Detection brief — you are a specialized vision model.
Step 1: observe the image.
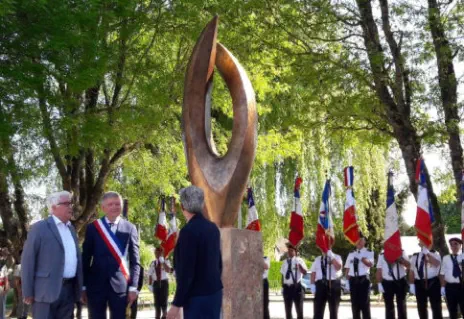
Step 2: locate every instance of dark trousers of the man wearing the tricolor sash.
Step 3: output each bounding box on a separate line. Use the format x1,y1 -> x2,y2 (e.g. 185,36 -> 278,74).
87,284 -> 127,319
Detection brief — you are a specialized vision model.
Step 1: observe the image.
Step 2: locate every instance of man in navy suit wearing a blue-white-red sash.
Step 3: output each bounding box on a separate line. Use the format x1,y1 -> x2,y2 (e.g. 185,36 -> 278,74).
82,192 -> 140,319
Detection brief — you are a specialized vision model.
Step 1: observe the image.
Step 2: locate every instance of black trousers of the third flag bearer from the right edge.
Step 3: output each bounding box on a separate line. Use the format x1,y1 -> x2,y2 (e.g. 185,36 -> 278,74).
382,278 -> 409,319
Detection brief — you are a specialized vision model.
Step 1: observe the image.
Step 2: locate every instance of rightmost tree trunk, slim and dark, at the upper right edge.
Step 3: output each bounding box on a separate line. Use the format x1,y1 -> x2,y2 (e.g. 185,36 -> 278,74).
428,0 -> 464,207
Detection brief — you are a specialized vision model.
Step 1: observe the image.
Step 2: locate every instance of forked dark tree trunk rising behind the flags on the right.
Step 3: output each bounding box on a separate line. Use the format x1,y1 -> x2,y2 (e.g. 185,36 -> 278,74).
356,0 -> 448,253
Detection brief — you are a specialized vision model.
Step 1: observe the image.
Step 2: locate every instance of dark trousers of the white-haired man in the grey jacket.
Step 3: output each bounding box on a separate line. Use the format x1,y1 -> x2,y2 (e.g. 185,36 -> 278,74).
32,281 -> 75,319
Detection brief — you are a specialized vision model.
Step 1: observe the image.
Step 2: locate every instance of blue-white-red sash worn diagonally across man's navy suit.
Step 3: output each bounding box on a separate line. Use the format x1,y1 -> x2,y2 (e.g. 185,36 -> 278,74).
93,217 -> 130,281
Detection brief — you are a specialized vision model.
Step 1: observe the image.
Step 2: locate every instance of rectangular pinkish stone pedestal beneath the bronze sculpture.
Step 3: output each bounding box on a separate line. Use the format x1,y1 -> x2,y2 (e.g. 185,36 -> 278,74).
221,228 -> 264,319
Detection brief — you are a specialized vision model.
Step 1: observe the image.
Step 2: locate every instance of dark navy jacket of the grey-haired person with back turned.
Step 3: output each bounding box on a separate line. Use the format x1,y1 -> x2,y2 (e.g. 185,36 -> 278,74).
172,214 -> 222,307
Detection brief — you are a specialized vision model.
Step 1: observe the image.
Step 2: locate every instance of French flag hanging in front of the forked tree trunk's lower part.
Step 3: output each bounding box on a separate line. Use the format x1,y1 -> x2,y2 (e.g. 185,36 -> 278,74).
414,158 -> 435,248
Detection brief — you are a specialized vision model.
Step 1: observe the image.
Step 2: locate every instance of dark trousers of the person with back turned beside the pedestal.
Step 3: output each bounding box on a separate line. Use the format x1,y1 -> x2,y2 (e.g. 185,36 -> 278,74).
184,289 -> 222,319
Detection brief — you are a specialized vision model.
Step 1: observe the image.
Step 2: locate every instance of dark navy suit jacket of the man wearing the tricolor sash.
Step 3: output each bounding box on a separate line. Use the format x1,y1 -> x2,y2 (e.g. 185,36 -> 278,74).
82,218 -> 140,293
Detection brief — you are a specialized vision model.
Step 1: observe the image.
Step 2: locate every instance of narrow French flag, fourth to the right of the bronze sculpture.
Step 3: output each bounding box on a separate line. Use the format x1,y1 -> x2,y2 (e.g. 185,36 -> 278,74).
343,166 -> 360,245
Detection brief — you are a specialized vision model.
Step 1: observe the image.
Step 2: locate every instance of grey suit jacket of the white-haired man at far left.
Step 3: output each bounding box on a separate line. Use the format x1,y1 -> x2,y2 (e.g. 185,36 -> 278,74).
21,217 -> 83,303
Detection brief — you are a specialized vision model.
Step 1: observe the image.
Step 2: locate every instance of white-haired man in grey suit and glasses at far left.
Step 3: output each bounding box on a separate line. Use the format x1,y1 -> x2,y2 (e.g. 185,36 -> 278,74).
21,191 -> 83,319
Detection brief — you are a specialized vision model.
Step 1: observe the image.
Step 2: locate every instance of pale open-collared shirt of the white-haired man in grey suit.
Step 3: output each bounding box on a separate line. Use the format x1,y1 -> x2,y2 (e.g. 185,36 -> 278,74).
52,215 -> 77,278
